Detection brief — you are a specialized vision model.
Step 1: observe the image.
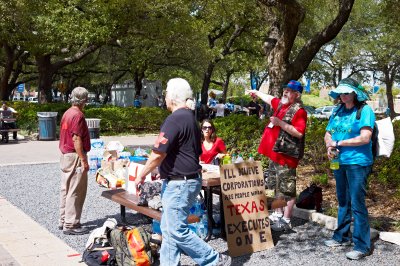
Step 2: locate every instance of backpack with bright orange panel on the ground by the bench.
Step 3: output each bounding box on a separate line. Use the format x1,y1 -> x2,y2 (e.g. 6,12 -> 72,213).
109,226 -> 154,266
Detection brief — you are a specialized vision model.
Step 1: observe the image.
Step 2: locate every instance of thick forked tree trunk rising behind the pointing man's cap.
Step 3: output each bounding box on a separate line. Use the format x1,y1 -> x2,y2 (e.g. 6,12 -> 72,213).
259,0 -> 354,96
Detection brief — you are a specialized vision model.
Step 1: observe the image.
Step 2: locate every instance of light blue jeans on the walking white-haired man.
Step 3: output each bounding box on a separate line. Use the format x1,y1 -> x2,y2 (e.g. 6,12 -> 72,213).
160,178 -> 219,266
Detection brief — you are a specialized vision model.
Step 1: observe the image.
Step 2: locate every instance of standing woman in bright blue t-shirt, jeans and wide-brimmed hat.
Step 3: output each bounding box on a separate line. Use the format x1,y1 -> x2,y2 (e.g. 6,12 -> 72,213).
324,78 -> 375,260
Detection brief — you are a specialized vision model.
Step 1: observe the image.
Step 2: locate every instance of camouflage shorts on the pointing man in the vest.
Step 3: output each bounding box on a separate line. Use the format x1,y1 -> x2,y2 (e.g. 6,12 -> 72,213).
265,161 -> 296,198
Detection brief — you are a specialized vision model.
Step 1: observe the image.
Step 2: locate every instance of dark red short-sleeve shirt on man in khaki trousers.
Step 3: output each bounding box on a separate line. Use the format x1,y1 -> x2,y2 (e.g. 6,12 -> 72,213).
59,107 -> 90,154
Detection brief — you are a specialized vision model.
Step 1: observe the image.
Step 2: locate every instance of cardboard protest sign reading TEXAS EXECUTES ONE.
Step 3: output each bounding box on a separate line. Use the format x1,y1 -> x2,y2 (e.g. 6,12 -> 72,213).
221,162 -> 274,257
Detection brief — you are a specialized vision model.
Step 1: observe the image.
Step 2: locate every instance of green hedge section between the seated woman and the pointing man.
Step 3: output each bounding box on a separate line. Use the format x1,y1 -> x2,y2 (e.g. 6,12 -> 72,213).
214,115 -> 267,167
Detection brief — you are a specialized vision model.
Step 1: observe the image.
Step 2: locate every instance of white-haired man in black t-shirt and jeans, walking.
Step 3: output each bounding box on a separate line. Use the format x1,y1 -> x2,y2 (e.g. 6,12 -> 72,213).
135,78 -> 231,266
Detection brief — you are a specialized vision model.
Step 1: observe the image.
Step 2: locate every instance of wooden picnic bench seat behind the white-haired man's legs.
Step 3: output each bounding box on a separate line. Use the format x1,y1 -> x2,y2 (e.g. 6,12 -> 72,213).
101,189 -> 200,223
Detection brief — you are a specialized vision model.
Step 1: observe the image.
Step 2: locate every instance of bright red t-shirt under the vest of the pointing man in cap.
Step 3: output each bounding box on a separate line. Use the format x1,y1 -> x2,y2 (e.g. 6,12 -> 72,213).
258,98 -> 307,168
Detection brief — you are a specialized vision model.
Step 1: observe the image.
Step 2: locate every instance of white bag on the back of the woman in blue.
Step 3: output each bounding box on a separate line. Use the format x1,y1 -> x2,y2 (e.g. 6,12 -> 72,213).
375,117 -> 395,158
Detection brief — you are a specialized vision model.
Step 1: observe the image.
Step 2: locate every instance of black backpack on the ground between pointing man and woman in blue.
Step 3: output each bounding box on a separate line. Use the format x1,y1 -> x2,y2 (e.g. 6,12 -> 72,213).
296,184 -> 322,212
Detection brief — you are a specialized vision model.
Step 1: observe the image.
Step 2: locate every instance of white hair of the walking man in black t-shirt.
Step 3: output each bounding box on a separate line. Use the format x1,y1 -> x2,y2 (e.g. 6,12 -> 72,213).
166,78 -> 193,109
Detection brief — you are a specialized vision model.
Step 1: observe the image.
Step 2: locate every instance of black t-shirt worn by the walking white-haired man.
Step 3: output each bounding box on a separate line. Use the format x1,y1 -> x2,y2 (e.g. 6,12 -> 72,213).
153,108 -> 201,179
